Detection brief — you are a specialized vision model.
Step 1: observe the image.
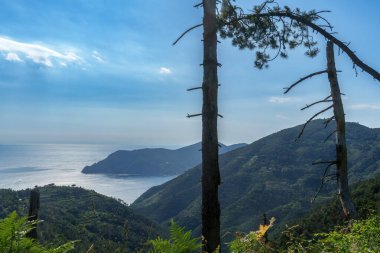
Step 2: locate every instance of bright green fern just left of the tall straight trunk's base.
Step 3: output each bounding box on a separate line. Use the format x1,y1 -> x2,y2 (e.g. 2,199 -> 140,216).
149,220 -> 202,253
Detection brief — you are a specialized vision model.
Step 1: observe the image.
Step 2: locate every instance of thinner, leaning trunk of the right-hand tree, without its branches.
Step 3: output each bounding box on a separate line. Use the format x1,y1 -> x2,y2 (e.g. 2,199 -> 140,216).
326,41 -> 356,219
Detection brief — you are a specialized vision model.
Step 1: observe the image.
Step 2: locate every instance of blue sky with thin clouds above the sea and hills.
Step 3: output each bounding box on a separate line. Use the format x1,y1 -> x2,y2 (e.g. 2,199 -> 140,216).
0,0 -> 380,147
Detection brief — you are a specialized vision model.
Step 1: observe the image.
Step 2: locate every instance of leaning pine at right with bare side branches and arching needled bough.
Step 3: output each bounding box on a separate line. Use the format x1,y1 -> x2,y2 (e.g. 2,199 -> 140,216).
219,0 -> 380,218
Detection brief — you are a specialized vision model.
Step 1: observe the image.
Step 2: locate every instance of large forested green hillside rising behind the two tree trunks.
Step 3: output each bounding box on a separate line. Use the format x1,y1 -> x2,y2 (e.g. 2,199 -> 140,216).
131,120 -> 380,237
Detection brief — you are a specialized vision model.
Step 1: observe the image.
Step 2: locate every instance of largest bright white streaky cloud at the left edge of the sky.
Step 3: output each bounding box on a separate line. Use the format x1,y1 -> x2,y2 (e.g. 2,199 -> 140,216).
0,37 -> 81,67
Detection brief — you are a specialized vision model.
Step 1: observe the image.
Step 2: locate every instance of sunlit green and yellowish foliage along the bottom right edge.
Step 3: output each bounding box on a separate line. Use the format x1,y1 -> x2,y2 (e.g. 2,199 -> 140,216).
229,216 -> 380,253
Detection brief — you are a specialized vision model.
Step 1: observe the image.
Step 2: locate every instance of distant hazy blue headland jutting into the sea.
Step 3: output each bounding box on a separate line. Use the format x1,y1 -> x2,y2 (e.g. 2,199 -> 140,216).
82,143 -> 247,176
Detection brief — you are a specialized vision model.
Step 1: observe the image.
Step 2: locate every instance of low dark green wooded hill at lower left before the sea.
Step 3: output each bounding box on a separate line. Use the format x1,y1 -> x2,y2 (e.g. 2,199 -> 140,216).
0,185 -> 163,253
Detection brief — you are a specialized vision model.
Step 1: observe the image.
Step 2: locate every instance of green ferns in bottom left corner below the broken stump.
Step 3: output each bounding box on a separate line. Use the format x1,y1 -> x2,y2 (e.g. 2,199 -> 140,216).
0,212 -> 75,253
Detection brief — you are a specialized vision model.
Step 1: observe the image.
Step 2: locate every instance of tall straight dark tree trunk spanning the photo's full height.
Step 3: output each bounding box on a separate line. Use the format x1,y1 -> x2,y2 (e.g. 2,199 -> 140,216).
202,0 -> 220,253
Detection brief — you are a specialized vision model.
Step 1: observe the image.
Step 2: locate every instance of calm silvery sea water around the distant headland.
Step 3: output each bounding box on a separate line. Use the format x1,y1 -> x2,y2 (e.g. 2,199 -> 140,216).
0,144 -> 173,203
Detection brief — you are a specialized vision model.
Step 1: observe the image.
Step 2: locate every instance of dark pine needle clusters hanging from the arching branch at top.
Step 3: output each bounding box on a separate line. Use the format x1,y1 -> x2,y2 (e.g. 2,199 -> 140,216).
218,0 -> 326,69
